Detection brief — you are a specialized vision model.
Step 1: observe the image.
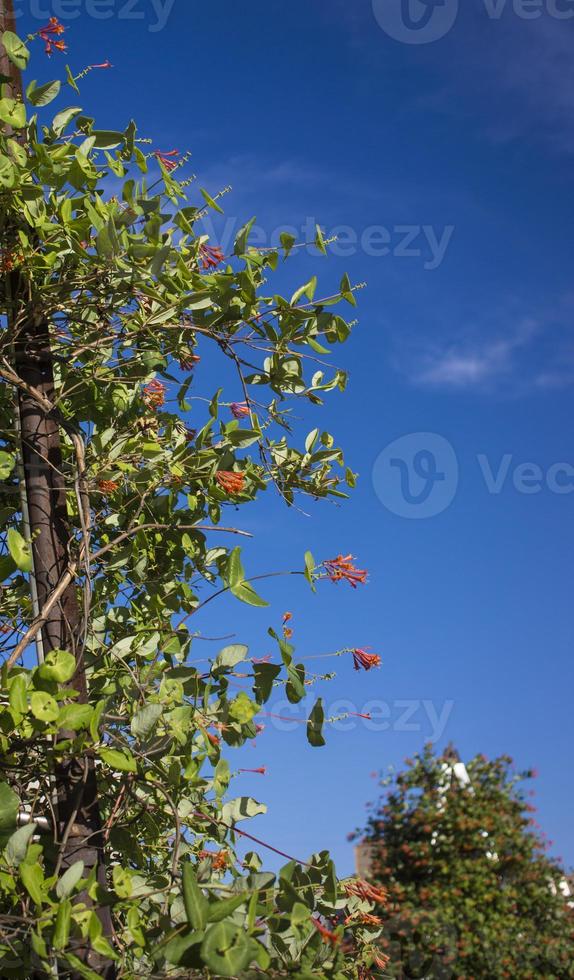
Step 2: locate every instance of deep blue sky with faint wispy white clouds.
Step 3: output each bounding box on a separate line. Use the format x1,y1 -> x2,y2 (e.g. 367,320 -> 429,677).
18,0 -> 574,872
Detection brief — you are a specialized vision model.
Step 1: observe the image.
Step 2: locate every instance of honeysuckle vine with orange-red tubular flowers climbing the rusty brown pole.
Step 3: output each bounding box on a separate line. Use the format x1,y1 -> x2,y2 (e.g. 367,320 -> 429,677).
0,18 -> 392,980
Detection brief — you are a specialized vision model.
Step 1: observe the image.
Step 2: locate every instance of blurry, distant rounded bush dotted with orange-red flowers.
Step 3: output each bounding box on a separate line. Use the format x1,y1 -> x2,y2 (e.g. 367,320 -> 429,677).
361,746 -> 574,980
